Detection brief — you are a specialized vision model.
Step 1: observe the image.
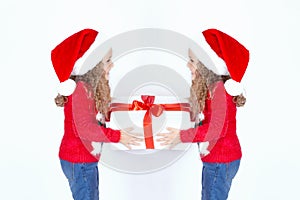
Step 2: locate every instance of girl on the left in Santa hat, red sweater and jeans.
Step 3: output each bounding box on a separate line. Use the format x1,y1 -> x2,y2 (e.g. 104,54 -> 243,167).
51,30 -> 140,200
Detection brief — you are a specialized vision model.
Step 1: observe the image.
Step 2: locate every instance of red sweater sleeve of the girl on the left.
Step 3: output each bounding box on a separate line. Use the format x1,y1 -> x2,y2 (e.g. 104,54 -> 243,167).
72,82 -> 120,142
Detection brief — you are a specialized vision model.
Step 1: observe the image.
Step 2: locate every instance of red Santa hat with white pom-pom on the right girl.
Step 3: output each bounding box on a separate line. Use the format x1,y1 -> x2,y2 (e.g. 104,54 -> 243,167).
202,29 -> 249,96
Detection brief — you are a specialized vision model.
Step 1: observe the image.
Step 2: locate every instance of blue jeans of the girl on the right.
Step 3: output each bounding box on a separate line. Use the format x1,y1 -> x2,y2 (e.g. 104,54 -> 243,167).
202,160 -> 240,200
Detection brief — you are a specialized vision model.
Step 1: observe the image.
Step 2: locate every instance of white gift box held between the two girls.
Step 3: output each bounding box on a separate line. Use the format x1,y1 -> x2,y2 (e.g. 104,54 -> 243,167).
107,96 -> 195,150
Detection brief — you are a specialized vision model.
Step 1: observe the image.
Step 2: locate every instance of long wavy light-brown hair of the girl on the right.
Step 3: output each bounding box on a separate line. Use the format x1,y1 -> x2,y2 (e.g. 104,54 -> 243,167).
189,60 -> 246,117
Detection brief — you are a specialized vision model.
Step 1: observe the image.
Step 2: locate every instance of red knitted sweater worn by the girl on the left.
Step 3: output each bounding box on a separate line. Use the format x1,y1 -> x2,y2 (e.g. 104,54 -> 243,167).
59,81 -> 120,163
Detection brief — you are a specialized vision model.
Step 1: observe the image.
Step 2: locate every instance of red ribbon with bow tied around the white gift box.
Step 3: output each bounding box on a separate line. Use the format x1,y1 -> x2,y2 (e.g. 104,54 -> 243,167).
111,95 -> 190,149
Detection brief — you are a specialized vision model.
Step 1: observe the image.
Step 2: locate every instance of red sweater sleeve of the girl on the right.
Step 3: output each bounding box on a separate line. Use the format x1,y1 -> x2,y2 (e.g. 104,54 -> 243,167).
180,82 -> 228,142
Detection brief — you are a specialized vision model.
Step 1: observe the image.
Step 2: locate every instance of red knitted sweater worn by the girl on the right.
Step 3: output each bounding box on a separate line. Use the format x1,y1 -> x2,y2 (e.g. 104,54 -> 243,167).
180,93 -> 242,163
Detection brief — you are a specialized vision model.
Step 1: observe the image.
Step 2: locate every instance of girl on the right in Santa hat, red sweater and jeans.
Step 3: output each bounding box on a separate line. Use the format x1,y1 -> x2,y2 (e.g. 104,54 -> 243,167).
159,29 -> 249,200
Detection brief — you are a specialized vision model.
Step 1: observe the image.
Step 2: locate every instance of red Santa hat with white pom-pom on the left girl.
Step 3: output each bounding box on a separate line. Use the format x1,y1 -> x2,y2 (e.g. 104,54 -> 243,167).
51,29 -> 98,96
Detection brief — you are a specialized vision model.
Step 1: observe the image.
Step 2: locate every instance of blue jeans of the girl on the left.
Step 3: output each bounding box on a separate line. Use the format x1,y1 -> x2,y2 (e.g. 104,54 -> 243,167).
60,160 -> 99,200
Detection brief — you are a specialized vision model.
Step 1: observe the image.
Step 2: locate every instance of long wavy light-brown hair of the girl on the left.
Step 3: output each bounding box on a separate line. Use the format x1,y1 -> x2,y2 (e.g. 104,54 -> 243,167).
54,61 -> 111,117
